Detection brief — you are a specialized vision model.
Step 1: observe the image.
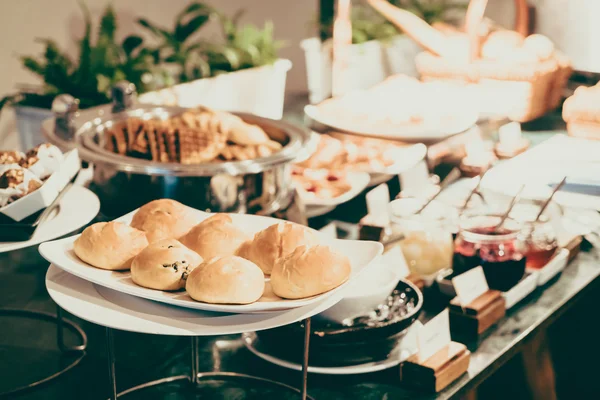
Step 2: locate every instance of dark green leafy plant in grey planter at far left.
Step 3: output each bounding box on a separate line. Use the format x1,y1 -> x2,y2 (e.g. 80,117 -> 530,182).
0,4 -> 154,149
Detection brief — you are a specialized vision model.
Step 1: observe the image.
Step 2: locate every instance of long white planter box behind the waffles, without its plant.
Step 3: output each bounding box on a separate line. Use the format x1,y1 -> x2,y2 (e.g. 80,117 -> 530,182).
139,59 -> 292,119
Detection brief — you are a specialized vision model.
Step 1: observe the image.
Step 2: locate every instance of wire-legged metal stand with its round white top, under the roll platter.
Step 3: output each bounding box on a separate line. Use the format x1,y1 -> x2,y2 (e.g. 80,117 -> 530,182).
46,265 -> 352,400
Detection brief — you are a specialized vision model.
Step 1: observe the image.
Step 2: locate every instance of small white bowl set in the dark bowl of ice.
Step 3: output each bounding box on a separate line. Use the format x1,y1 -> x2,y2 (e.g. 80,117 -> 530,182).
319,258 -> 400,324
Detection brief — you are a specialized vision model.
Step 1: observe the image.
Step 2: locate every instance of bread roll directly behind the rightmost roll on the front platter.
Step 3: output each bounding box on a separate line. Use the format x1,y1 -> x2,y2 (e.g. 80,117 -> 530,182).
238,222 -> 319,275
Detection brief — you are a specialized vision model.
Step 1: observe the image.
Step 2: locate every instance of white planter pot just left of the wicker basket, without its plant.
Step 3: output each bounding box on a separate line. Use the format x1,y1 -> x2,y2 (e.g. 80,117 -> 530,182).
300,35 -> 419,104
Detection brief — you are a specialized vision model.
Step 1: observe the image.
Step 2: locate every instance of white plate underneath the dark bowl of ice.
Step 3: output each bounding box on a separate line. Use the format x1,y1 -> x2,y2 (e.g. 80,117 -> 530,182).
242,333 -> 416,375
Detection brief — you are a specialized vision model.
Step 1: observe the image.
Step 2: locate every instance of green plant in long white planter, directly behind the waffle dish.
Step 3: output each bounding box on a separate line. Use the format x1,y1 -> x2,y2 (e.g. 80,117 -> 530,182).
138,3 -> 291,119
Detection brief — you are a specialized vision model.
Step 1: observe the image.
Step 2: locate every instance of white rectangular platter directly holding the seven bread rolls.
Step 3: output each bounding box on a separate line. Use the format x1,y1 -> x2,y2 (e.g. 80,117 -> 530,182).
39,210 -> 383,313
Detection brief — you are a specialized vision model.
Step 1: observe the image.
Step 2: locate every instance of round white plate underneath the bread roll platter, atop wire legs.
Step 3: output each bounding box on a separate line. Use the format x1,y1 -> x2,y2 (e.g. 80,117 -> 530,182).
46,265 -> 358,338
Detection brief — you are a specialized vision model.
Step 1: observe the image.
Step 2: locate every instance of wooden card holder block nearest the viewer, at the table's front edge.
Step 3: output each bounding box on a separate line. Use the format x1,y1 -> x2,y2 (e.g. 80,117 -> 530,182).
400,342 -> 471,393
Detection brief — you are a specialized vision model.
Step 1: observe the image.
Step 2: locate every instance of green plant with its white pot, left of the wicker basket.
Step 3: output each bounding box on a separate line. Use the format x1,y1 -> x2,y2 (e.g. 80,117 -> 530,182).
301,0 -> 465,103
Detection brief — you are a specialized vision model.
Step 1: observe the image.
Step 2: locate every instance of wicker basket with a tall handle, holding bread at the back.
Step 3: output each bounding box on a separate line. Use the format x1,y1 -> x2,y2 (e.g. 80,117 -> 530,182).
416,0 -> 572,122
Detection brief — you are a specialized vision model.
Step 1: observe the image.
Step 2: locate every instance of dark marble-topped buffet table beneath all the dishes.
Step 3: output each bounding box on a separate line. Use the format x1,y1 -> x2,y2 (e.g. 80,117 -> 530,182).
0,99 -> 600,400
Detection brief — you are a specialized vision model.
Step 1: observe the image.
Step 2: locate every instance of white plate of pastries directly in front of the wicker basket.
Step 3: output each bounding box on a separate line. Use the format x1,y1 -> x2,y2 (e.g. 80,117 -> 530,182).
304,105 -> 478,143
